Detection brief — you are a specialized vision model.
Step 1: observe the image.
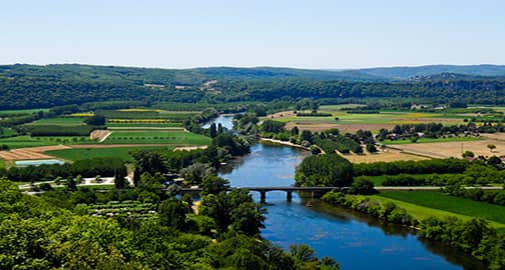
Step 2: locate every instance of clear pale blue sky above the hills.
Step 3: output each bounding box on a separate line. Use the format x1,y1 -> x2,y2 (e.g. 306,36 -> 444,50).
0,0 -> 505,68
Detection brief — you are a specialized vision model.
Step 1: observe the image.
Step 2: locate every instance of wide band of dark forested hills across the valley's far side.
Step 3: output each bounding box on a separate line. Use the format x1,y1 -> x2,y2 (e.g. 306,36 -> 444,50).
0,65 -> 505,109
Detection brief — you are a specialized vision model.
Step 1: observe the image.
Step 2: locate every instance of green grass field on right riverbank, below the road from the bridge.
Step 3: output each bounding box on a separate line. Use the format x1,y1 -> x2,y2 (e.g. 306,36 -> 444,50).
377,191 -> 505,226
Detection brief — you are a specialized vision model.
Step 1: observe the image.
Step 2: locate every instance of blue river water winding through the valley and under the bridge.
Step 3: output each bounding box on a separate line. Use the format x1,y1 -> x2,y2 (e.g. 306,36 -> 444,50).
208,117 -> 486,270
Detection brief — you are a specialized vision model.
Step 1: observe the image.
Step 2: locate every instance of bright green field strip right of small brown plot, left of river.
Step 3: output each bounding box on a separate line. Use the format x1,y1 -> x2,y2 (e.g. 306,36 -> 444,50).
103,130 -> 211,145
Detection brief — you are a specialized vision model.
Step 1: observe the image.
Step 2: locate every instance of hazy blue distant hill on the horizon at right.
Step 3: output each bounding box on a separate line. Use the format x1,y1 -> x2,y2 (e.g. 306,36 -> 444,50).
356,65 -> 505,80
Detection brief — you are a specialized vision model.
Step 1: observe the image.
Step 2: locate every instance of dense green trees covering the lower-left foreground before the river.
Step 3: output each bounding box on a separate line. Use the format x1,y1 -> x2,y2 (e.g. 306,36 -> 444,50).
0,174 -> 338,269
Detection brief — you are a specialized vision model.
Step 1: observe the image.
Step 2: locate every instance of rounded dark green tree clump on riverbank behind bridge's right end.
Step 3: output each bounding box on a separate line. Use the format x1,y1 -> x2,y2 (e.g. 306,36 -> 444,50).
295,154 -> 352,186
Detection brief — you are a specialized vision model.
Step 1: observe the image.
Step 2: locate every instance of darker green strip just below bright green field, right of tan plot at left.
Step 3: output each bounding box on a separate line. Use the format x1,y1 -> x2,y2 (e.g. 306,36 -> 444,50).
45,146 -> 174,161
